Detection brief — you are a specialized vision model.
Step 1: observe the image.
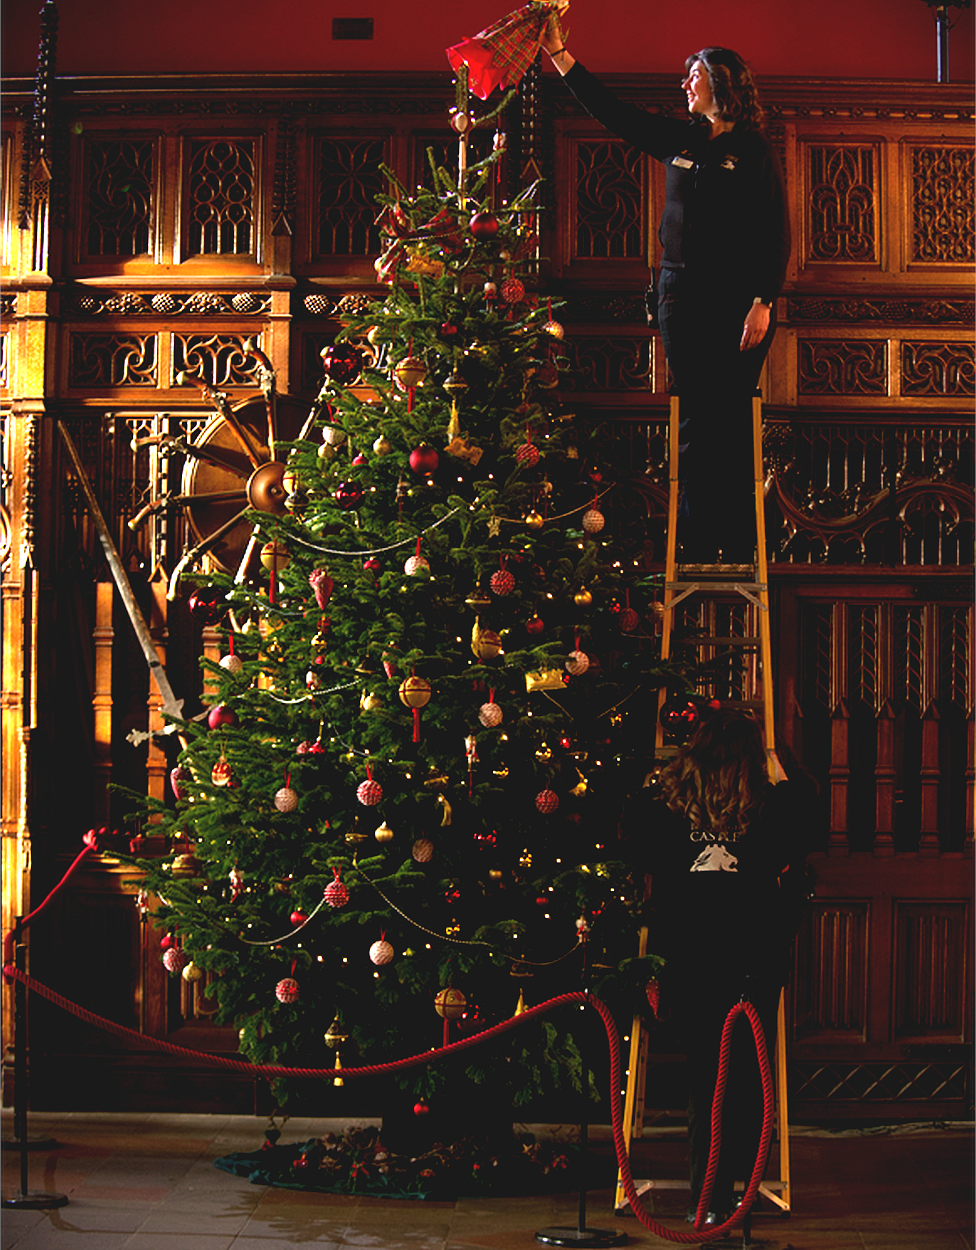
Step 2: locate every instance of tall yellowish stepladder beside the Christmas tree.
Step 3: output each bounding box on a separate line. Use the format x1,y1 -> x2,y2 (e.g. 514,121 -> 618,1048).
614,393 -> 791,1211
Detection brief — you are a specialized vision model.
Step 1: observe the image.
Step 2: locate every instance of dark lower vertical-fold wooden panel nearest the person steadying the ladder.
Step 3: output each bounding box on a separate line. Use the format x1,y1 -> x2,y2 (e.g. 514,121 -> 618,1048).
794,899 -> 870,1039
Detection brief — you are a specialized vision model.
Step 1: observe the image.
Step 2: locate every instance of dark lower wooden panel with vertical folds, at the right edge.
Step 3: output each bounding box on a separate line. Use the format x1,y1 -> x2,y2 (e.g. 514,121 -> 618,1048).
895,901 -> 966,1041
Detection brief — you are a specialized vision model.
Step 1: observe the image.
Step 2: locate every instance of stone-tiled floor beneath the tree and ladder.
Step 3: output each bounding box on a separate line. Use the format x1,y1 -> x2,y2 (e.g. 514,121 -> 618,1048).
0,1113 -> 975,1250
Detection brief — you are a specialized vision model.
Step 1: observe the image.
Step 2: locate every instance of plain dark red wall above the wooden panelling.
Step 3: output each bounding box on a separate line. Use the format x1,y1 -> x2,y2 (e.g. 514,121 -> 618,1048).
0,0 -> 976,81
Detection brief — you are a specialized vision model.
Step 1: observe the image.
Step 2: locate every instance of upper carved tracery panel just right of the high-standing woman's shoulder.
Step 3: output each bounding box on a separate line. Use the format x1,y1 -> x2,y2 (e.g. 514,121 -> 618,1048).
807,144 -> 880,265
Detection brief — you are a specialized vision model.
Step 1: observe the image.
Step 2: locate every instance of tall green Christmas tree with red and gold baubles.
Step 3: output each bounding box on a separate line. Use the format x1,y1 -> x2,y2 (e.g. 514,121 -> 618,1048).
121,100 -> 666,1135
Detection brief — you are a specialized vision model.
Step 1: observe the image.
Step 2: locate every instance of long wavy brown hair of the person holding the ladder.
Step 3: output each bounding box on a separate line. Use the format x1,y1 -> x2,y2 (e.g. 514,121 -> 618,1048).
661,711 -> 770,834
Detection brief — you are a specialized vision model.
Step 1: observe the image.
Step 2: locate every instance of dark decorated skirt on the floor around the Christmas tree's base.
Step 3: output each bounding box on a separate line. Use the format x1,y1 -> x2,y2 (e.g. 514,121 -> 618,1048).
214,1128 -> 615,1200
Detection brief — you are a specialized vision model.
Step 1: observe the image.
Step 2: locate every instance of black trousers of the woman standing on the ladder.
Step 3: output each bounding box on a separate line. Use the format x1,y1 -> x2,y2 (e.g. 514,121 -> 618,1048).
657,269 -> 775,564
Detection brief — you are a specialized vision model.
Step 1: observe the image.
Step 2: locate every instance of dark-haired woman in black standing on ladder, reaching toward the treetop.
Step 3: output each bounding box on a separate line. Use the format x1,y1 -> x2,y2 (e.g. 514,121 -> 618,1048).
542,4 -> 790,564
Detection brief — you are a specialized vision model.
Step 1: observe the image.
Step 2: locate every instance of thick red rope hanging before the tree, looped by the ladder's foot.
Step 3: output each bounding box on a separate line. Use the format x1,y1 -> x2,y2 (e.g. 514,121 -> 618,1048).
4,955 -> 772,1245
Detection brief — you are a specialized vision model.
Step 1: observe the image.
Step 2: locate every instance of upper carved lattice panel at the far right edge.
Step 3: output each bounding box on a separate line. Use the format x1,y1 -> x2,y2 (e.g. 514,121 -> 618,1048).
911,145 -> 976,265
